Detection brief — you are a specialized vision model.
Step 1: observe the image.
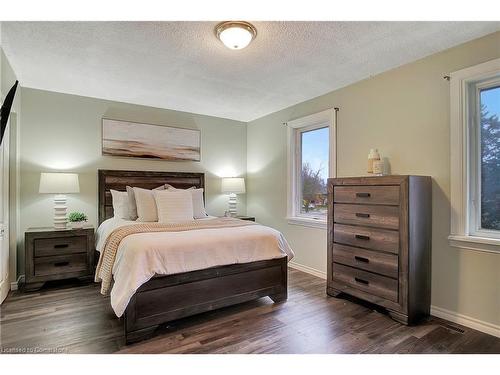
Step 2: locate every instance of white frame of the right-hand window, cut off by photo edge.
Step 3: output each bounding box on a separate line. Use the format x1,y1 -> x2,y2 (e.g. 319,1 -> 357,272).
448,59 -> 500,252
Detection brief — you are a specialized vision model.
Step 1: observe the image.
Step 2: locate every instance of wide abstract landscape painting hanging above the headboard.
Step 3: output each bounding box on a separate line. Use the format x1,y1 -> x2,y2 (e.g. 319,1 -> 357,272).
102,118 -> 201,161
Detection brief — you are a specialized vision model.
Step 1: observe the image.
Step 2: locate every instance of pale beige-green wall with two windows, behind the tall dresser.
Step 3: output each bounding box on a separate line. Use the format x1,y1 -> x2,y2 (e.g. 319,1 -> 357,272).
247,33 -> 500,325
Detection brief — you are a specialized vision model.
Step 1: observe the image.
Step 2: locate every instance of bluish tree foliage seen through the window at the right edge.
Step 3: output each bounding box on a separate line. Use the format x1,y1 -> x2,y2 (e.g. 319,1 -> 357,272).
481,106 -> 500,230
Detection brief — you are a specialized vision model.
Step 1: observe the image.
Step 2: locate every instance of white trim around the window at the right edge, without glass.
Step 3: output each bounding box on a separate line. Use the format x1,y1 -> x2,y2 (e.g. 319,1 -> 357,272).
448,59 -> 500,252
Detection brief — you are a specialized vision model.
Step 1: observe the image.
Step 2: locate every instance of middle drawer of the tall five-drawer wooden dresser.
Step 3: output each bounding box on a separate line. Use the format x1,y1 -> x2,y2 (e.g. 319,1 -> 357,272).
333,224 -> 399,254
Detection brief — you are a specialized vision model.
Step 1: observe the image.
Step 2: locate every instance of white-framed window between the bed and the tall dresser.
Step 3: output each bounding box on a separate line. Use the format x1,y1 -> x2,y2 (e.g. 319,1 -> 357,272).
287,109 -> 335,228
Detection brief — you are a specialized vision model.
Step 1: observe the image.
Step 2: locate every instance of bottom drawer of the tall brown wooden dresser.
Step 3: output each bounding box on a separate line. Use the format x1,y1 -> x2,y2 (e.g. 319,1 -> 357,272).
332,263 -> 398,302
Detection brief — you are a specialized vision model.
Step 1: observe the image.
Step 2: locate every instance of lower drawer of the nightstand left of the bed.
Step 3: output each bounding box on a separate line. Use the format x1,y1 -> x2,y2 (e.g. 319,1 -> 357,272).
35,253 -> 88,276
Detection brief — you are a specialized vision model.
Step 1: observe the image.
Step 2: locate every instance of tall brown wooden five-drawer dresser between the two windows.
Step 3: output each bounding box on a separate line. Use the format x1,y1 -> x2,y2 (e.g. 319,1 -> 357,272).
327,176 -> 432,324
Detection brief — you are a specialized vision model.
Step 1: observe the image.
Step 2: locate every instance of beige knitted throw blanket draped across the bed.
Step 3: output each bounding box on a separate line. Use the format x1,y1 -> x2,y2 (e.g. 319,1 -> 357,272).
95,218 -> 256,295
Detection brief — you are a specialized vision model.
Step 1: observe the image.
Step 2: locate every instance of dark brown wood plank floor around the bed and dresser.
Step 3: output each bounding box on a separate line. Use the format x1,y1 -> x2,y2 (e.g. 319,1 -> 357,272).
0,269 -> 500,353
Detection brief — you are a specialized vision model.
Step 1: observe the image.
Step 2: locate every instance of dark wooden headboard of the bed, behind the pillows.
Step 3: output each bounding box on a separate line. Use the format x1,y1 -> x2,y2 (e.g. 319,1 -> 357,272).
98,169 -> 205,224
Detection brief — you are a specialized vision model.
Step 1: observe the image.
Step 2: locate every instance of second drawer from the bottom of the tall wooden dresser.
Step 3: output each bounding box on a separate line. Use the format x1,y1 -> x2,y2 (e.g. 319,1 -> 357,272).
332,243 -> 398,279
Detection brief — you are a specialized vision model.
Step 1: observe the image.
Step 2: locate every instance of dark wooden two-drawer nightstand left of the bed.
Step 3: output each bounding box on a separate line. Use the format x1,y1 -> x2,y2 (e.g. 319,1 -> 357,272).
24,227 -> 95,291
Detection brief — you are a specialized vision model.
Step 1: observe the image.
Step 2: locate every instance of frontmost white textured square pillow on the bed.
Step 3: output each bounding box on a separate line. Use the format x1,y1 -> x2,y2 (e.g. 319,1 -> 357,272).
153,189 -> 193,224
